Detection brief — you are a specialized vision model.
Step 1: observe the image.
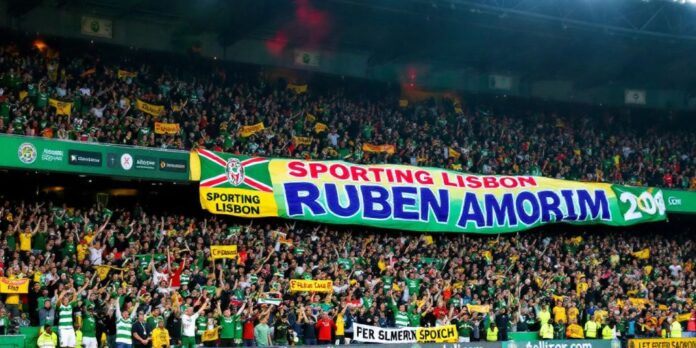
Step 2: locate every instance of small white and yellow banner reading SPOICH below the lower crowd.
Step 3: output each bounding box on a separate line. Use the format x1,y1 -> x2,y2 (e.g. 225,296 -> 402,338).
353,323 -> 459,344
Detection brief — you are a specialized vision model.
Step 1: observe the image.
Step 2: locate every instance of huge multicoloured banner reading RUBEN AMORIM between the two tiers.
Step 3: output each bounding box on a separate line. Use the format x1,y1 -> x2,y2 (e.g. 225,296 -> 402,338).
198,150 -> 665,234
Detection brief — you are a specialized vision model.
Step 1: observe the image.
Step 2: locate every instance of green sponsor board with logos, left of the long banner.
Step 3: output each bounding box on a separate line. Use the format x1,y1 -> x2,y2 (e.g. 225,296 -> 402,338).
0,134 -> 189,181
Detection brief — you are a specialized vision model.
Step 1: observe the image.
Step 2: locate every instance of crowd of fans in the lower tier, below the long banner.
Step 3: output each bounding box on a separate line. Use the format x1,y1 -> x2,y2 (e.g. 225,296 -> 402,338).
0,197 -> 696,347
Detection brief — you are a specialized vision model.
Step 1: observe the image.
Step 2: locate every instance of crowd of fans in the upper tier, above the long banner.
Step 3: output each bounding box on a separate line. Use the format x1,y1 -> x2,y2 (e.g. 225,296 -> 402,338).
0,38 -> 696,189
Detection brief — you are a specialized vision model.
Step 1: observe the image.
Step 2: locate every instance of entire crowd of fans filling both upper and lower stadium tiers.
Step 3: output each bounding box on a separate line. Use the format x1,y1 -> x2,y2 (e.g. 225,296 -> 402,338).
0,36 -> 696,347
